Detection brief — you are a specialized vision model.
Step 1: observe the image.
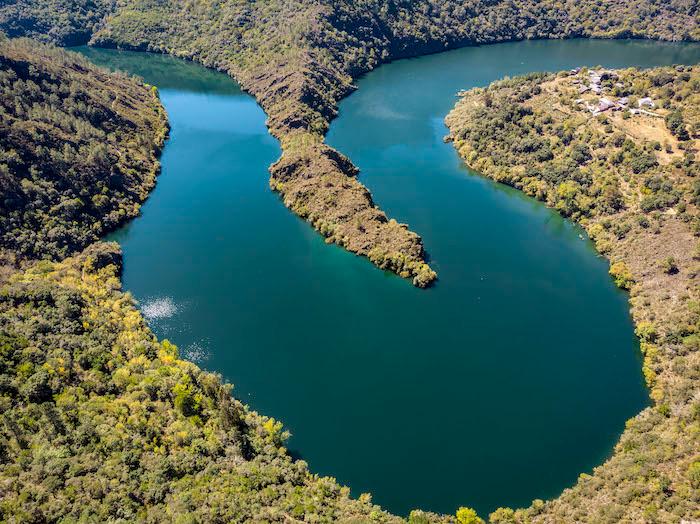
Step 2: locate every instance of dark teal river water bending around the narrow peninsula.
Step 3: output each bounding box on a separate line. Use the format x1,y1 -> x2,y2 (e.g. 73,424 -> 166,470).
75,41 -> 700,515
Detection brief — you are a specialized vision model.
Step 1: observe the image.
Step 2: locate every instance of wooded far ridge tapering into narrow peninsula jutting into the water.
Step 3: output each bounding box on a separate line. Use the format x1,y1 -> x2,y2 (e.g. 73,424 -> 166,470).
0,0 -> 700,286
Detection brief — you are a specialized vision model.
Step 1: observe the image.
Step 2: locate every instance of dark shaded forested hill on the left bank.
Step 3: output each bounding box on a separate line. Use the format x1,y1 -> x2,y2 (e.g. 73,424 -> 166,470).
0,39 -> 167,260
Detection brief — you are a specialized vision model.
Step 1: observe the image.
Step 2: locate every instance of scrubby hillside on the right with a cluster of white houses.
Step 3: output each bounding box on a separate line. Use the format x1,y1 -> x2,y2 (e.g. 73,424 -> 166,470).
446,66 -> 700,522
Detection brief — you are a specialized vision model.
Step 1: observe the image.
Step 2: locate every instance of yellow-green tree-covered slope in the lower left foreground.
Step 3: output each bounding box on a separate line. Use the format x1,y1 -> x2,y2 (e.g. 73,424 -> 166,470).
0,243 -> 426,522
